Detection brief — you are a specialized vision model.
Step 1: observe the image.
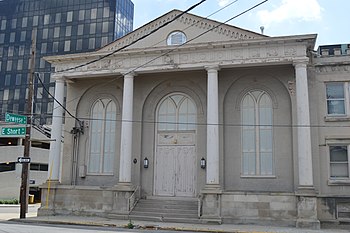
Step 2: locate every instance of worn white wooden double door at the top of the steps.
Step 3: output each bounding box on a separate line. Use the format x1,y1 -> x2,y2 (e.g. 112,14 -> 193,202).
154,132 -> 196,197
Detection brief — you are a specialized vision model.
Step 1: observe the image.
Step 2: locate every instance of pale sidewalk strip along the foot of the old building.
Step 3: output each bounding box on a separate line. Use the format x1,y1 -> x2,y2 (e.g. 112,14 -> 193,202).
10,216 -> 350,233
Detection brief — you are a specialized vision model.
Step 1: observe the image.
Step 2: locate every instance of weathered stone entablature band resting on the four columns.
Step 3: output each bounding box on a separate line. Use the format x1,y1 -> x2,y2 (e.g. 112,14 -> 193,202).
55,44 -> 308,77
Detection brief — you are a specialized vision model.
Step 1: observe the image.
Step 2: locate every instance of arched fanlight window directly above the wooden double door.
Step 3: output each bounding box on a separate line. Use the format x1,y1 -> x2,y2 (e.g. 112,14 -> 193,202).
158,94 -> 197,131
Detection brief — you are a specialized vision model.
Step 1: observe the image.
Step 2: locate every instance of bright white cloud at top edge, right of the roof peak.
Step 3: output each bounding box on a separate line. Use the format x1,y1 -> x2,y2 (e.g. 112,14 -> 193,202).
258,0 -> 322,27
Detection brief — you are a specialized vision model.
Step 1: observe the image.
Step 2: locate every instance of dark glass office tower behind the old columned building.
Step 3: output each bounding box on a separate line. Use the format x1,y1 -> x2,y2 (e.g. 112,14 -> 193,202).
0,0 -> 134,124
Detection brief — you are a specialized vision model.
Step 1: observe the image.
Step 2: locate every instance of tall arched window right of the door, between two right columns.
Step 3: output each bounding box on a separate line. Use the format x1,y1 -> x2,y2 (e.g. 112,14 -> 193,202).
241,90 -> 273,176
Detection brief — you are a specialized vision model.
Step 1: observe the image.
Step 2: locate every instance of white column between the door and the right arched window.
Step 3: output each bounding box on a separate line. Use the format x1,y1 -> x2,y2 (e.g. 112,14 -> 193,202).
206,66 -> 220,186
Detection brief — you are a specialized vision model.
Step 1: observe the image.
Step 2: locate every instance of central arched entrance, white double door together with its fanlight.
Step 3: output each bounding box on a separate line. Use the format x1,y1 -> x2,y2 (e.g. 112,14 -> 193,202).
154,93 -> 197,197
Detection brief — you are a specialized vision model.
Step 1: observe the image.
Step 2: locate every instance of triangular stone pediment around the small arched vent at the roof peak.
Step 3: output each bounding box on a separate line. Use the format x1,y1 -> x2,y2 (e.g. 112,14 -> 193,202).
100,10 -> 266,51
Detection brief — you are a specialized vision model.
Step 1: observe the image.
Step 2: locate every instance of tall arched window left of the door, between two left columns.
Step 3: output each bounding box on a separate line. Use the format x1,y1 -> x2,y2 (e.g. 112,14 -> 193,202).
88,99 -> 116,174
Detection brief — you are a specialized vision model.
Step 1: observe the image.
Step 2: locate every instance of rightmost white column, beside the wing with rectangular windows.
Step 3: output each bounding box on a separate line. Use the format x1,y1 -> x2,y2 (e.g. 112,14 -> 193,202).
294,58 -> 314,188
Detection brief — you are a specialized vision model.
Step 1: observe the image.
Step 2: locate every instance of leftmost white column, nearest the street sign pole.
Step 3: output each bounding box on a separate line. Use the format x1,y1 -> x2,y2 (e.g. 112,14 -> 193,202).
47,77 -> 65,181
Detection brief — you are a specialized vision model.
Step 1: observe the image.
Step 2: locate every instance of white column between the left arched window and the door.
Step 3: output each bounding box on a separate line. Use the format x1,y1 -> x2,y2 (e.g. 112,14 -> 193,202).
119,73 -> 134,184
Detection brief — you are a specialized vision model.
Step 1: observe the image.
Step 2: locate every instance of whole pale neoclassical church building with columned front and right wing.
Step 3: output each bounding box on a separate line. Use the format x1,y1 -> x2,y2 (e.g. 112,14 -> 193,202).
39,10 -> 350,229
